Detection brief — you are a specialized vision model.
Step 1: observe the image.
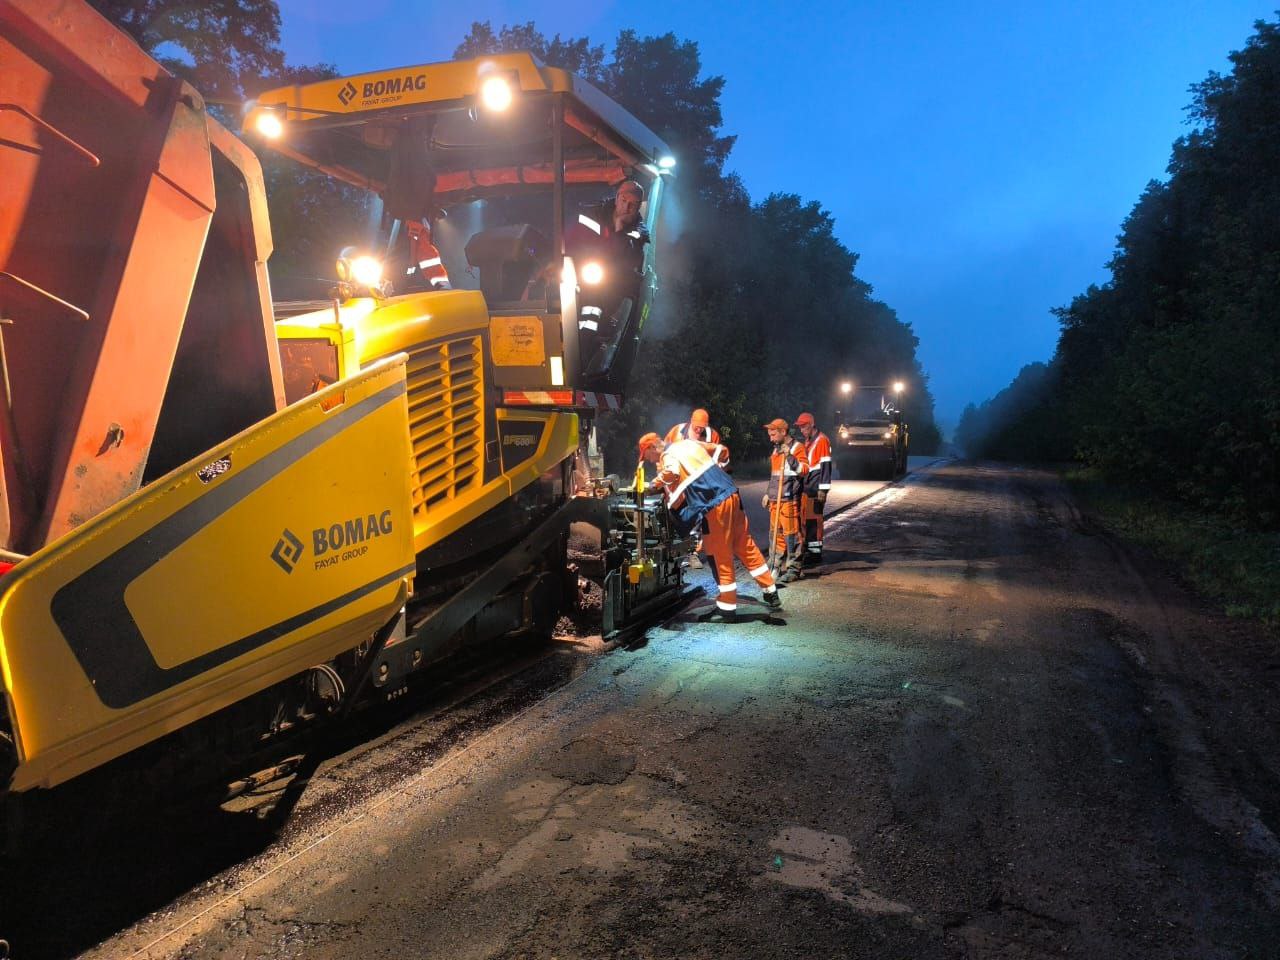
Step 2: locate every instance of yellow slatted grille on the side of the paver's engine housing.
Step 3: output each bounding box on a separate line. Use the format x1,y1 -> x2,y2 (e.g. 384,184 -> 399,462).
408,337 -> 484,522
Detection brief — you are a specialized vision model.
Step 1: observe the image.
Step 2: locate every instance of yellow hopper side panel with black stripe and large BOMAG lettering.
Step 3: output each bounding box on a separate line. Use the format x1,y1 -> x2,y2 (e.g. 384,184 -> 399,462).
0,355 -> 413,790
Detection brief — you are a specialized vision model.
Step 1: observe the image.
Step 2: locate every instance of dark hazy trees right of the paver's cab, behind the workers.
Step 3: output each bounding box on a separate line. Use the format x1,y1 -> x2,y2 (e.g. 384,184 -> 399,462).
456,17 -> 938,467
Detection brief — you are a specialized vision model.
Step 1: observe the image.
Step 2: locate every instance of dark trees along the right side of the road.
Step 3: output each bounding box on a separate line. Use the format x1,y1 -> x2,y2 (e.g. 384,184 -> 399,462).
957,20 -> 1280,529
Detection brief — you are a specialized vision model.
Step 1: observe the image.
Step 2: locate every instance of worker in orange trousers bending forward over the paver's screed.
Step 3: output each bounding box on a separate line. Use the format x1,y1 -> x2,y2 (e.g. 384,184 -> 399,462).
640,434 -> 782,622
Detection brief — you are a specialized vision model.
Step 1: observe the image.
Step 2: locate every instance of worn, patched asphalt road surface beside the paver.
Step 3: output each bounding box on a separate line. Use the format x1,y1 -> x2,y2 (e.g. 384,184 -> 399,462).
67,465 -> 1280,960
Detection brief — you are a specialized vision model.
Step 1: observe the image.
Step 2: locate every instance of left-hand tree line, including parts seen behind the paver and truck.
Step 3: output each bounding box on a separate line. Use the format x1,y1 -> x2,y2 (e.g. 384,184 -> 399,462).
82,0 -> 940,470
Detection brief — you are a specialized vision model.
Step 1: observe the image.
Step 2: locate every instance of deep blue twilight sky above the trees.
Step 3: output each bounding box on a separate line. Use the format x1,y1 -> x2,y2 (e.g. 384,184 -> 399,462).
280,0 -> 1276,426
